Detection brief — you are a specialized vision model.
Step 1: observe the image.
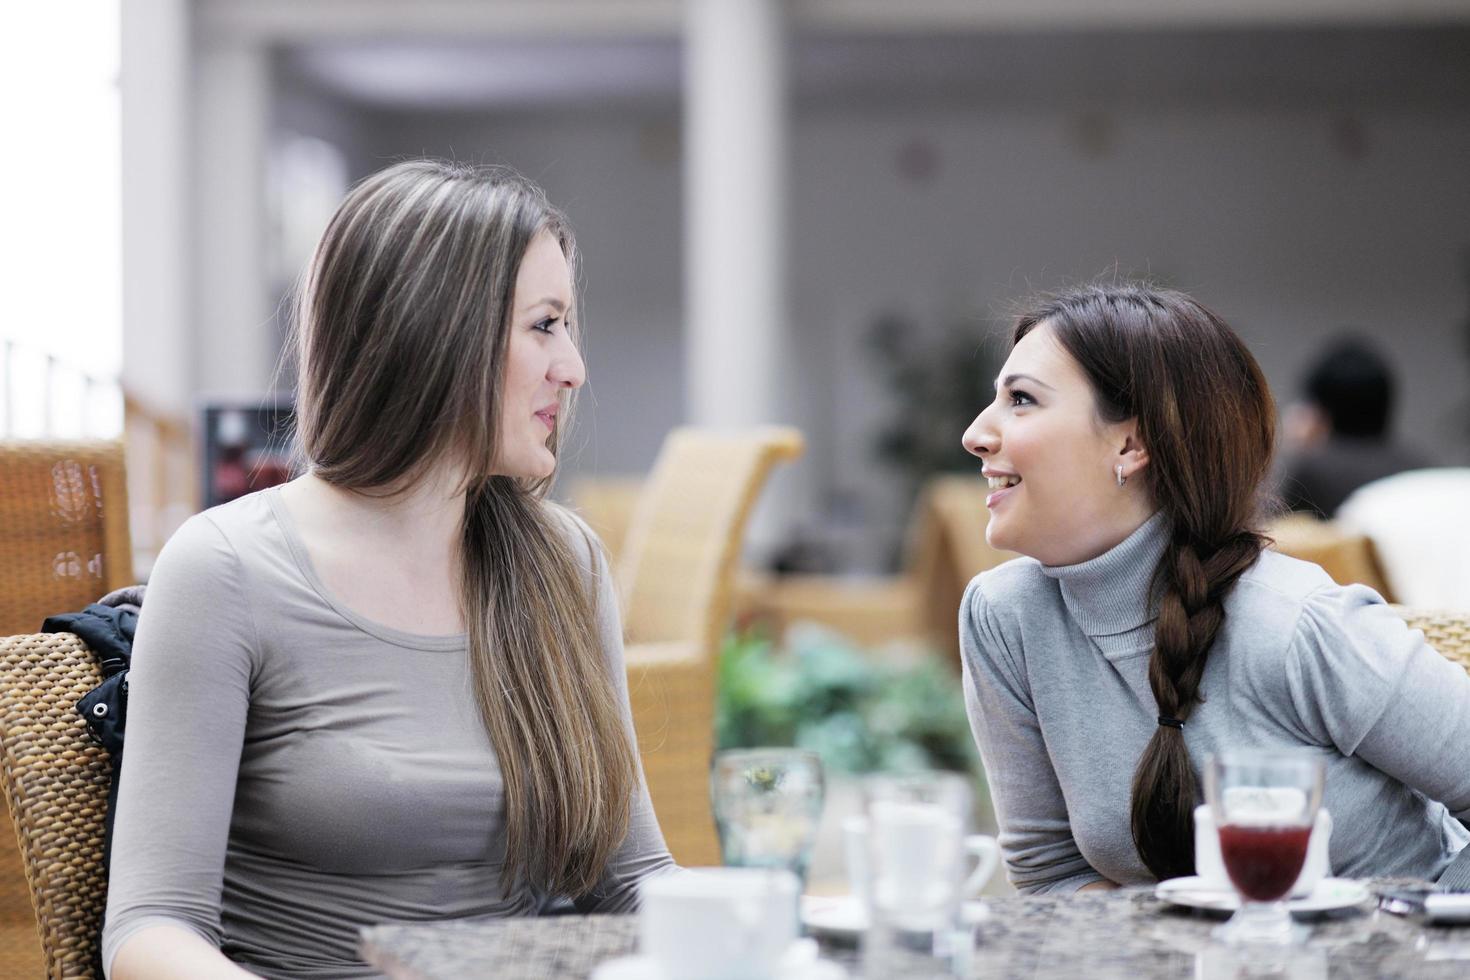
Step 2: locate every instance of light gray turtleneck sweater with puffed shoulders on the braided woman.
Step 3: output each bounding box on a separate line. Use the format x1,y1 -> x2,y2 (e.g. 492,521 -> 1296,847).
960,514 -> 1470,892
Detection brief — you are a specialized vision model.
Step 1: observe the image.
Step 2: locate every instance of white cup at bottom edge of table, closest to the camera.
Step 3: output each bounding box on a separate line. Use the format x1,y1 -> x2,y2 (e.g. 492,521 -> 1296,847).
638,868 -> 801,980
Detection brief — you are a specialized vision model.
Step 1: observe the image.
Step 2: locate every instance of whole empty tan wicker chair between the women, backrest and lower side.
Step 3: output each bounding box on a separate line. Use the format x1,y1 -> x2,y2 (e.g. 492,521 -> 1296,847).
617,428 -> 804,865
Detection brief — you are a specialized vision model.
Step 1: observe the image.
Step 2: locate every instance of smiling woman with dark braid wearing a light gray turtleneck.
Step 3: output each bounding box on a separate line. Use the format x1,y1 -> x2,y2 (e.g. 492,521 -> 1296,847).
960,285 -> 1470,892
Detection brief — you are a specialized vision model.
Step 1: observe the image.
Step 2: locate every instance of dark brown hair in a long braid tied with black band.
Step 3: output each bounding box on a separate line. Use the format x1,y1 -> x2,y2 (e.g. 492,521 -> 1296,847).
1013,284 -> 1276,879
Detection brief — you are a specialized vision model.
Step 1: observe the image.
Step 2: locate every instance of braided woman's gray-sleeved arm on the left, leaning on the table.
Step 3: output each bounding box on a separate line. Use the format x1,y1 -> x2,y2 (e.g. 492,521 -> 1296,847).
960,580 -> 1105,893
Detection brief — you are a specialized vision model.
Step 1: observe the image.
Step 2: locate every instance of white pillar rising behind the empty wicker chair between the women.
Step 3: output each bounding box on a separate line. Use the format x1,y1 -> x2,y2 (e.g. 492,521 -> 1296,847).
684,0 -> 797,551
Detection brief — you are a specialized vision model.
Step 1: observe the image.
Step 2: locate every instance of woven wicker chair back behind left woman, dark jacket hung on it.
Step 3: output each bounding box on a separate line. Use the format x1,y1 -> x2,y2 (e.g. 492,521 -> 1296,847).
0,633 -> 112,980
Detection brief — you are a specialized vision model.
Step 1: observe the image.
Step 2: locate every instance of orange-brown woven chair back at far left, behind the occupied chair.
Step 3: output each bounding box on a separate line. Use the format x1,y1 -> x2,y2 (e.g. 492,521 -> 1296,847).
0,442 -> 134,636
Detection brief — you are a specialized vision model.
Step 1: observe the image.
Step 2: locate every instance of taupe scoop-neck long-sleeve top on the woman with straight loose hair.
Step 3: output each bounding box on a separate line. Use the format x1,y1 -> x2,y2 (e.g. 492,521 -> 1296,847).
103,489 -> 673,977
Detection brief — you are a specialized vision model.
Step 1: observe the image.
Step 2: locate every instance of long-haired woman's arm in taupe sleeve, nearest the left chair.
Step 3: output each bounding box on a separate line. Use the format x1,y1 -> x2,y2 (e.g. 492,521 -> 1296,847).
103,516 -> 259,977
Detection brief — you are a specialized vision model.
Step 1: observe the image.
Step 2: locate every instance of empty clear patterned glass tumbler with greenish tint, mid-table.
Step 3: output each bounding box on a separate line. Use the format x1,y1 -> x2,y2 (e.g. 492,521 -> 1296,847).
710,748 -> 825,886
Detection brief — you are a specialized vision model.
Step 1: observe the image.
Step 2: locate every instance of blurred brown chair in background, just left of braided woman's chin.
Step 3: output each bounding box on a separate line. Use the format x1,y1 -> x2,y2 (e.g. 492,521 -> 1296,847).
741,475 -> 1014,658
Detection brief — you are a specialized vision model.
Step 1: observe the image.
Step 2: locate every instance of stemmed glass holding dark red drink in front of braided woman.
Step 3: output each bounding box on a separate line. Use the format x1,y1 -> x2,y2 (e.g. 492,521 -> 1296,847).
1204,749 -> 1324,945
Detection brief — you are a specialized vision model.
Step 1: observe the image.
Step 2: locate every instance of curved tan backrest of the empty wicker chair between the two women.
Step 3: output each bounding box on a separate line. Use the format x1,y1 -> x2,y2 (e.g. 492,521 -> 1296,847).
619,428 -> 804,657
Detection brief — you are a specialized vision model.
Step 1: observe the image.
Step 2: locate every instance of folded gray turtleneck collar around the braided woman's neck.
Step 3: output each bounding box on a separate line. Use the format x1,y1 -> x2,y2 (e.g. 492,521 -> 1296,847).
1041,511 -> 1169,636
